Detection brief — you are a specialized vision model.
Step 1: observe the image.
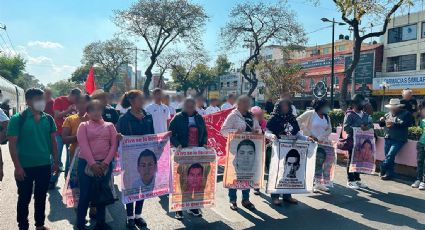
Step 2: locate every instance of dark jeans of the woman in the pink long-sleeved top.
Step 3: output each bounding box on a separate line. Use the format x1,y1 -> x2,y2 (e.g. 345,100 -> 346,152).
77,158 -> 112,229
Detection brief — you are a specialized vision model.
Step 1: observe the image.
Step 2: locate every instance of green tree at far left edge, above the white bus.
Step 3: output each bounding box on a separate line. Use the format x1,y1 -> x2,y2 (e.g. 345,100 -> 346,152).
0,55 -> 26,84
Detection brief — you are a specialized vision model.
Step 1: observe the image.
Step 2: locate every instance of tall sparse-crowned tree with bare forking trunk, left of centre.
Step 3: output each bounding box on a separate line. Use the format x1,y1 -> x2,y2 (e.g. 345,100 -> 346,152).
115,0 -> 208,94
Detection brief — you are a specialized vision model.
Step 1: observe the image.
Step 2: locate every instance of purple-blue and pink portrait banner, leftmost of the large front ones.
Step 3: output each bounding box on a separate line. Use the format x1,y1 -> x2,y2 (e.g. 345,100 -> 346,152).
119,132 -> 171,204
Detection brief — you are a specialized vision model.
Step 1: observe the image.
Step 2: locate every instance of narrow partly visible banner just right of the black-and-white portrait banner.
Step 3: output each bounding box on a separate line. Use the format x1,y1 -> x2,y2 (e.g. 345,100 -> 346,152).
314,144 -> 336,187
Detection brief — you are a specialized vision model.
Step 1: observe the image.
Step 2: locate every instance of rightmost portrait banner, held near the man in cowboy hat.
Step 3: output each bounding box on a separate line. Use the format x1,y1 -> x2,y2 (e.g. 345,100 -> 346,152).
349,127 -> 376,174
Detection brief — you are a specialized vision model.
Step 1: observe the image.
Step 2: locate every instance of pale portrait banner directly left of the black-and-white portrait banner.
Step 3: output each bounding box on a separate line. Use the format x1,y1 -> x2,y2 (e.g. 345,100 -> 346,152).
223,133 -> 265,189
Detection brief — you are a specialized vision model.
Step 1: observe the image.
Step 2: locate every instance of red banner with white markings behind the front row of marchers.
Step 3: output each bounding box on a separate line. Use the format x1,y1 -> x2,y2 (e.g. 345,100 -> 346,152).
203,109 -> 232,165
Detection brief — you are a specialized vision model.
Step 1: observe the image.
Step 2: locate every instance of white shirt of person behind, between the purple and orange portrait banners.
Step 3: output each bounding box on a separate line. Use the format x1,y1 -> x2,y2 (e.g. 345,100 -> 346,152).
146,103 -> 171,133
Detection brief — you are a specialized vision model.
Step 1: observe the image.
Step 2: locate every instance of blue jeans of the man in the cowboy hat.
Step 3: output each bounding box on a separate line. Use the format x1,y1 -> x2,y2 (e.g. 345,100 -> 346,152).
381,138 -> 405,176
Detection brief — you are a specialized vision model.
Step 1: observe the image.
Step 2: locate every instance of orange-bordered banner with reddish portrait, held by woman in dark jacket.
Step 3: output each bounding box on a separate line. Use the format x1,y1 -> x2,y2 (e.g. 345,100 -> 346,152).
169,147 -> 217,212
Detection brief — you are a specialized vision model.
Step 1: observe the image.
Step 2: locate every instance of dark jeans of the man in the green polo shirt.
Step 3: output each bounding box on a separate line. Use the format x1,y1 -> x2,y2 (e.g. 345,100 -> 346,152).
16,165 -> 51,230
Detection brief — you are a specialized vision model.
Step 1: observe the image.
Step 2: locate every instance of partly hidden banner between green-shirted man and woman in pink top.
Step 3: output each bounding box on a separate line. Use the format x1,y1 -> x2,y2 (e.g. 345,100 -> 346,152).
62,147 -> 80,208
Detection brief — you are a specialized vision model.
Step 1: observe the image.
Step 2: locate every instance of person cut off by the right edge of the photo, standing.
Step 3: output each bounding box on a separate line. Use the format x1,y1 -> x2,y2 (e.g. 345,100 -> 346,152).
412,107 -> 425,190
